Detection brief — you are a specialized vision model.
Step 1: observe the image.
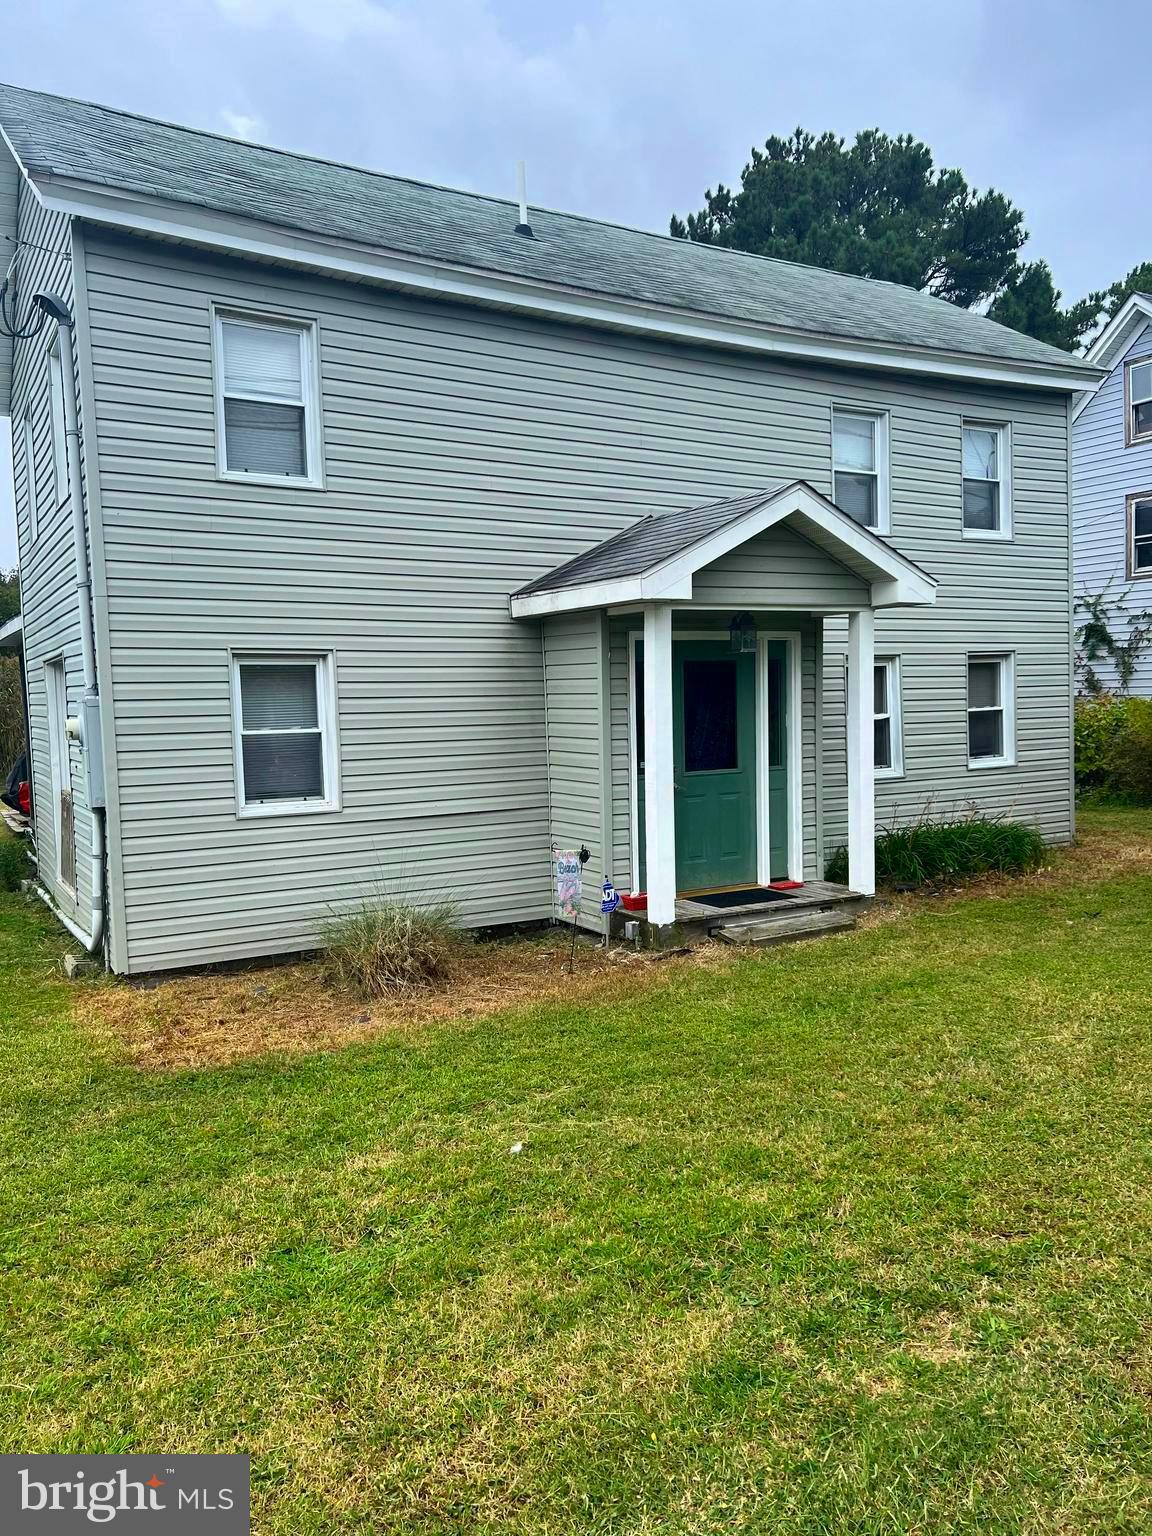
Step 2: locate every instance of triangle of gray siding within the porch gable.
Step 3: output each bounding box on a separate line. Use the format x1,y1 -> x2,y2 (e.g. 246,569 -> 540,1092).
693,528 -> 871,610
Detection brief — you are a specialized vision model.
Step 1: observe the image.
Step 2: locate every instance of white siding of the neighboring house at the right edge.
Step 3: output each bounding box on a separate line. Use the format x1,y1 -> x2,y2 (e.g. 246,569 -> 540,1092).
1072,324 -> 1152,696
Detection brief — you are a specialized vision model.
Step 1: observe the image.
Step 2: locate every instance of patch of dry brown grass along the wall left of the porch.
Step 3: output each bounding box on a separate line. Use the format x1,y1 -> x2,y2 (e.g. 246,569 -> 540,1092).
77,932 -> 731,1071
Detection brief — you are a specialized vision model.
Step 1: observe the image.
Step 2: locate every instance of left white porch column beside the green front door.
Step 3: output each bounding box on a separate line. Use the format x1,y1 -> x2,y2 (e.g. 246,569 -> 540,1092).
644,602 -> 676,925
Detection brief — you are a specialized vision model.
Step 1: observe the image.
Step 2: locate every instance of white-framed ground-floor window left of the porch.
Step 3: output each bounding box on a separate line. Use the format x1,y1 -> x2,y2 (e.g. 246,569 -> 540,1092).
232,653 -> 339,816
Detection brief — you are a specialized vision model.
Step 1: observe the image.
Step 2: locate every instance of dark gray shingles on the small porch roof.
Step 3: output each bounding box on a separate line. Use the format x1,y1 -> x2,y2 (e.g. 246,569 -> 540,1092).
513,481 -> 920,598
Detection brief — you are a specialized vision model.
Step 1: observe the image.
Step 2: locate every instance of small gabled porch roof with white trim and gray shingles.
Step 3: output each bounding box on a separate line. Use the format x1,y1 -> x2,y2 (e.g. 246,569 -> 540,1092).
510,481 -> 937,619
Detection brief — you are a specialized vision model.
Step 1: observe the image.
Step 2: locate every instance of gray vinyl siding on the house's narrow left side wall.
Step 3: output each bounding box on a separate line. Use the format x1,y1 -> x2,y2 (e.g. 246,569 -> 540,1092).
12,181 -> 92,929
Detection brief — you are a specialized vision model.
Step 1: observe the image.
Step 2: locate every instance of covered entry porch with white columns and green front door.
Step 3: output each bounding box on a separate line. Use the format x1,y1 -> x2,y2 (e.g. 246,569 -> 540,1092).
511,482 -> 935,928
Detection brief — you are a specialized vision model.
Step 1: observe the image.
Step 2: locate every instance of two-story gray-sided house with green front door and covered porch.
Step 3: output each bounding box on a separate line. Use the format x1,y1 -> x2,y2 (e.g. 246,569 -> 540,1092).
0,88 -> 1100,972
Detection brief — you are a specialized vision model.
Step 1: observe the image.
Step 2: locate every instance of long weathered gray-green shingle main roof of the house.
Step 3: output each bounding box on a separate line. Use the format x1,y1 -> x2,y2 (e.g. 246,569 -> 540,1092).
0,86 -> 1099,369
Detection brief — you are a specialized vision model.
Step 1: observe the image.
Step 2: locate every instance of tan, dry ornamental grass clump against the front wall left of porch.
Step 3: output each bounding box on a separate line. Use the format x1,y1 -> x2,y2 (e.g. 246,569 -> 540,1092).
321,897 -> 464,997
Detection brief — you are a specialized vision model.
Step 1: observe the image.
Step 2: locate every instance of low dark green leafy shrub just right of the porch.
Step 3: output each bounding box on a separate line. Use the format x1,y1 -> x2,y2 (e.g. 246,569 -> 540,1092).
826,814 -> 1048,885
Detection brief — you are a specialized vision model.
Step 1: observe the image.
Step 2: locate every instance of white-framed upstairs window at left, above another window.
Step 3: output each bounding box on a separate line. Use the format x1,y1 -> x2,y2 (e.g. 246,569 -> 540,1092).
214,310 -> 321,485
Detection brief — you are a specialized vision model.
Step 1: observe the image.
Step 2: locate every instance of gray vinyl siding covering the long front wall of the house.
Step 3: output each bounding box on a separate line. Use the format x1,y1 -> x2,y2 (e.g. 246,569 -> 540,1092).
86,232 -> 1069,971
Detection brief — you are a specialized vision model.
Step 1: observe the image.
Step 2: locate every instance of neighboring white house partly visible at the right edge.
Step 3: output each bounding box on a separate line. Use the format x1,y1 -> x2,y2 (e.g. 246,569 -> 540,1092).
1072,293 -> 1152,696
